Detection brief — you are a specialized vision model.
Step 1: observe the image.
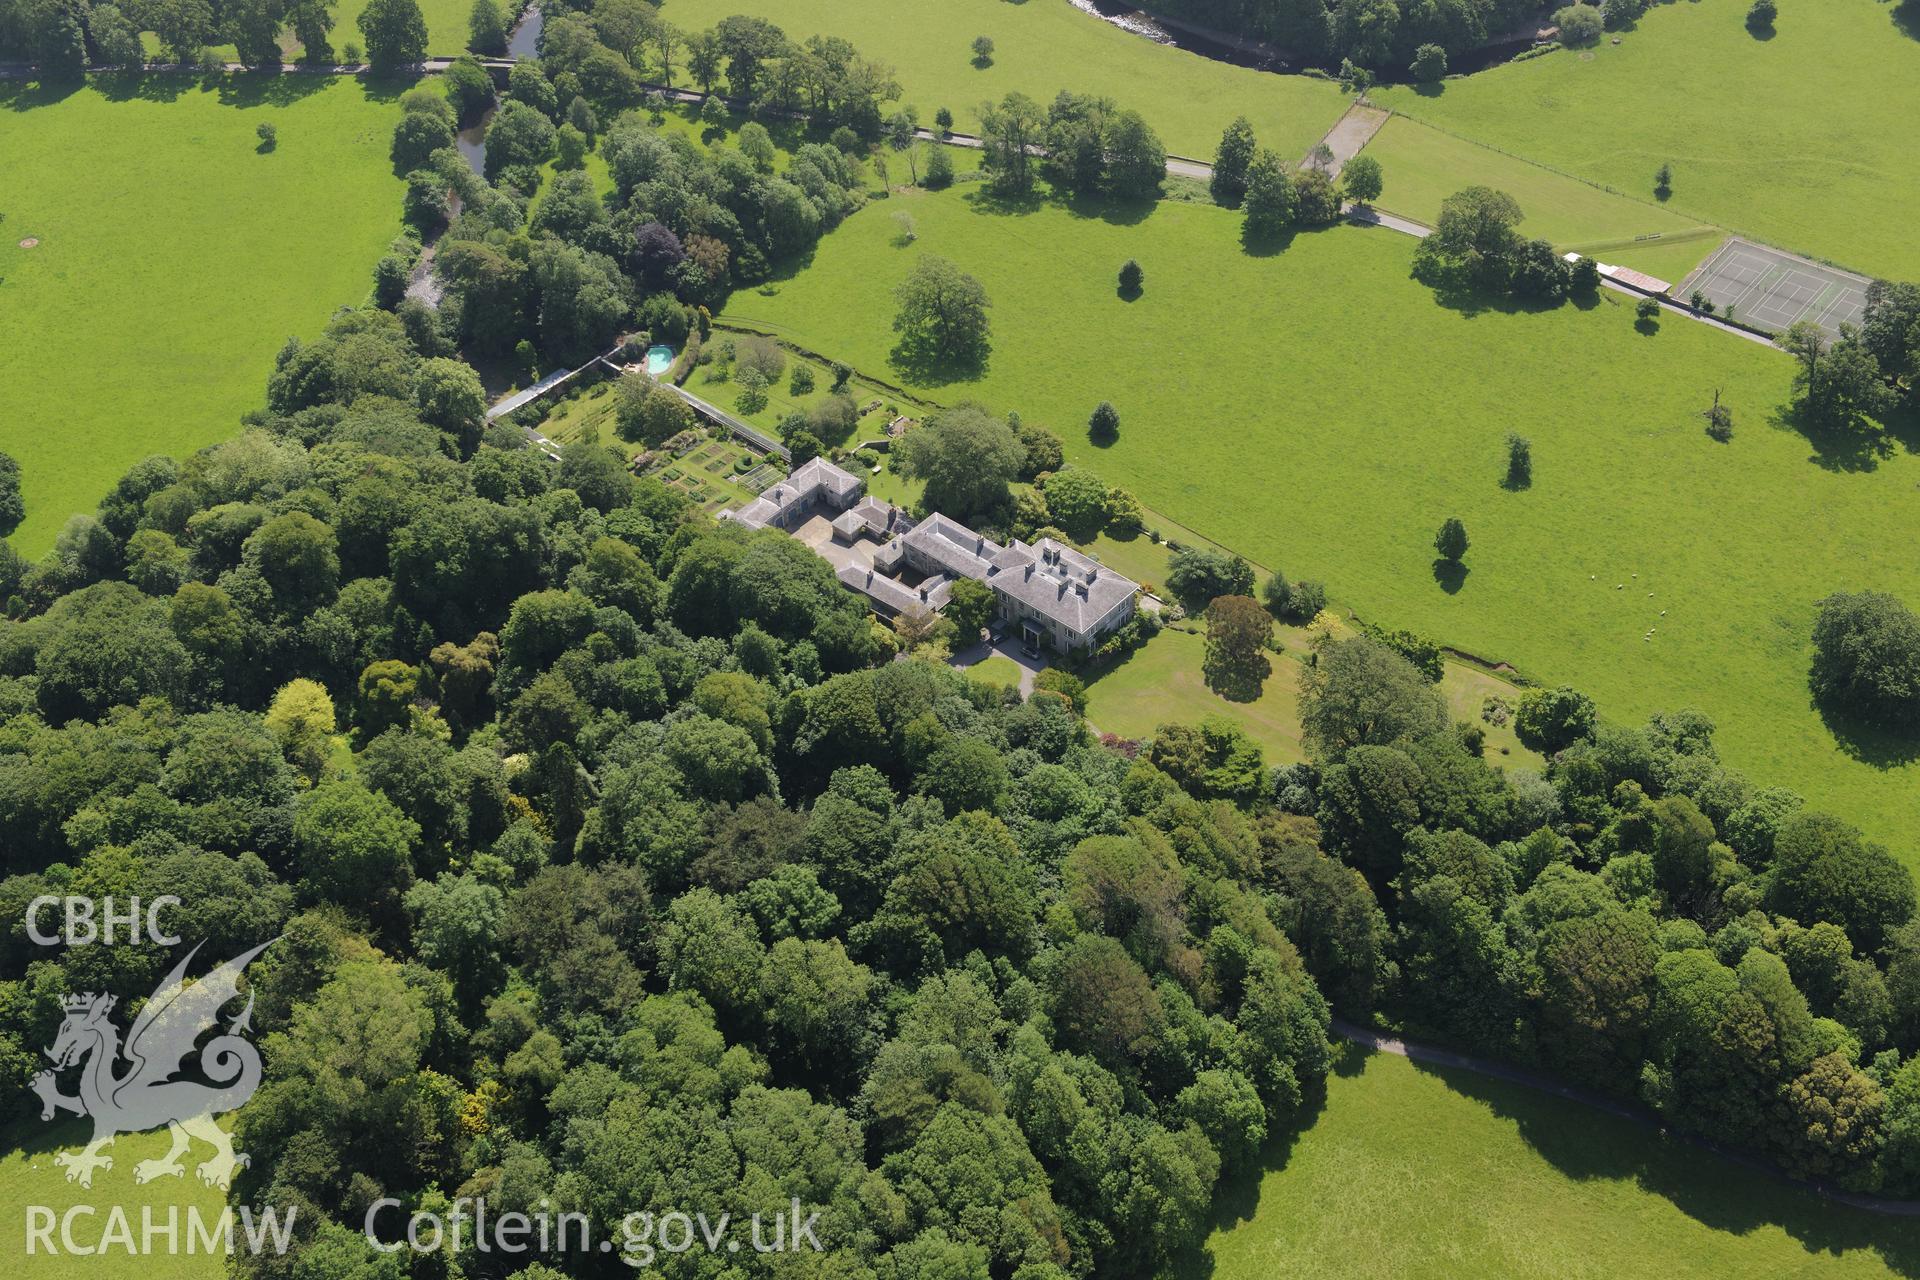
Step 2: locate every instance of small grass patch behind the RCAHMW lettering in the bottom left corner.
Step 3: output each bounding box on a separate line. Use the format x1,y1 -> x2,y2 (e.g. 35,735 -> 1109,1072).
0,1111 -> 231,1280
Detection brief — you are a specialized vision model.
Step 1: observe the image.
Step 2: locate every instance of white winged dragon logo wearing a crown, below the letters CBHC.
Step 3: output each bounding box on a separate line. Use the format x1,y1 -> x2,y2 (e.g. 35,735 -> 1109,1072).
33,940 -> 273,1190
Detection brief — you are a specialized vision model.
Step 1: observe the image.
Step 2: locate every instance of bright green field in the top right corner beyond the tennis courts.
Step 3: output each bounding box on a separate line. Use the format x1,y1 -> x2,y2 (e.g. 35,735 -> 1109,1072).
1373,0 -> 1920,278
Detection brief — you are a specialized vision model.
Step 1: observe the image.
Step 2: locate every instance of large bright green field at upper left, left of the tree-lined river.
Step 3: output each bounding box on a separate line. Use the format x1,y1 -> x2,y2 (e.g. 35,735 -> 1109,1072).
0,77 -> 401,557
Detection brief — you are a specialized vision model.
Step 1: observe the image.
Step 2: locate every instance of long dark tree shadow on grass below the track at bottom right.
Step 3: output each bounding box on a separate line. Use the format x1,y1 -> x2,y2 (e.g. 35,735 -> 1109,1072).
1413,1063 -> 1920,1276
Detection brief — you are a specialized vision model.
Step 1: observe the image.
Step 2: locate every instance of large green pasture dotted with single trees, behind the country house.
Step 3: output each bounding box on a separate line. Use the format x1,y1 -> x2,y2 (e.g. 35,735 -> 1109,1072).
726,190 -> 1920,864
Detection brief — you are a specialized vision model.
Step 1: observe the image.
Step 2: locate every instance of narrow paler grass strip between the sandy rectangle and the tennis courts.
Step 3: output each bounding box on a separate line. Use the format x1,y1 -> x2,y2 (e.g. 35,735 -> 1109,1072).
1367,115 -> 1726,284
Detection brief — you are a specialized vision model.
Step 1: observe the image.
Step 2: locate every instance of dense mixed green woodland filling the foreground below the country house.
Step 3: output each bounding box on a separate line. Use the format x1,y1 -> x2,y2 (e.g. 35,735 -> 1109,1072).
11,293 -> 1920,1280
